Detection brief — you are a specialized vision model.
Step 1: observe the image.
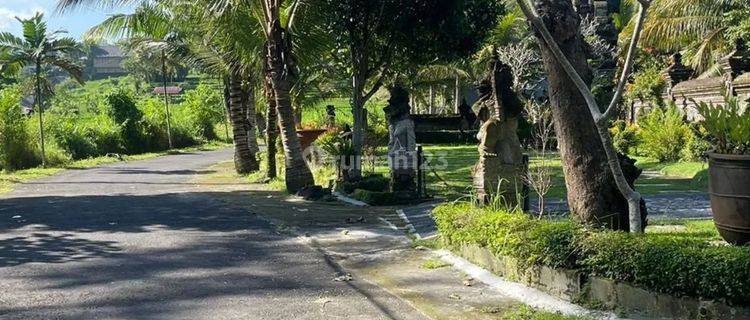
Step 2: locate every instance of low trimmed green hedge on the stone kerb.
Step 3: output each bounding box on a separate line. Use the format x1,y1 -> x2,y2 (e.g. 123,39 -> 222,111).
434,204 -> 750,306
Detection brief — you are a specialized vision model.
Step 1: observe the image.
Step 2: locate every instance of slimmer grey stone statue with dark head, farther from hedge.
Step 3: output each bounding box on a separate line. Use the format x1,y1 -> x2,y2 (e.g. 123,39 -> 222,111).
383,85 -> 417,197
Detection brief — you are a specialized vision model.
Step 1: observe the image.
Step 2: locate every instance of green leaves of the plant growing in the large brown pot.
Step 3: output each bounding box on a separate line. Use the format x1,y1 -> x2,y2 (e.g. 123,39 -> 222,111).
693,96 -> 750,154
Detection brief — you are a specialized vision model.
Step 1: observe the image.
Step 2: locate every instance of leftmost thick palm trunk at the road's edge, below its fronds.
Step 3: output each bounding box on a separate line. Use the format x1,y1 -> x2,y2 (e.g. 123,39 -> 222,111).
229,74 -> 259,174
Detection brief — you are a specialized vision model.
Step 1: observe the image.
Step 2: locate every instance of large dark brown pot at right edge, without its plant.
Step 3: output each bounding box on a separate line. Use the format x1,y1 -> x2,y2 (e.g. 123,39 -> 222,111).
709,153 -> 750,245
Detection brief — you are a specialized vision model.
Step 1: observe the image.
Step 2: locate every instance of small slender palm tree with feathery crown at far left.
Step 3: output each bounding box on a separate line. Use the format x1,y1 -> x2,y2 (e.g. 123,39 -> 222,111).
0,13 -> 84,166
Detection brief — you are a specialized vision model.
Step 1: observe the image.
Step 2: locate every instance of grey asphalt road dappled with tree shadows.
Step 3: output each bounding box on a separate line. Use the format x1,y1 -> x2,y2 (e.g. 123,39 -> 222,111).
0,150 -> 423,319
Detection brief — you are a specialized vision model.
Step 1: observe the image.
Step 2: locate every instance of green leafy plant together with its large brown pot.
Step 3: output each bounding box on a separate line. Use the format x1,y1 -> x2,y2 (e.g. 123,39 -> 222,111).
693,96 -> 750,245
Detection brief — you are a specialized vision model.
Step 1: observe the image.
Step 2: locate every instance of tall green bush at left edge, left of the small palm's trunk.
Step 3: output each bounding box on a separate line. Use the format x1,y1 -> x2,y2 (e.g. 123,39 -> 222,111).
0,87 -> 40,170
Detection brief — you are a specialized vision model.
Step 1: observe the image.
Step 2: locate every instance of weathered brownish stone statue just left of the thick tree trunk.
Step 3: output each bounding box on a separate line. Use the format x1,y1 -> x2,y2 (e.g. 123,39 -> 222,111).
474,52 -> 525,202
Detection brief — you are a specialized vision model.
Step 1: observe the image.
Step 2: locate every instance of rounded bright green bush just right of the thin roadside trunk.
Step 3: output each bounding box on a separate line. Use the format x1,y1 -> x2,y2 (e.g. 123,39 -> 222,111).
182,83 -> 224,140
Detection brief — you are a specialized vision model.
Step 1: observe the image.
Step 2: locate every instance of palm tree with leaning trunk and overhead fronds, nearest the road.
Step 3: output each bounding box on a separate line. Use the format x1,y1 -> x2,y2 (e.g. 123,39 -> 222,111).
58,0 -> 325,192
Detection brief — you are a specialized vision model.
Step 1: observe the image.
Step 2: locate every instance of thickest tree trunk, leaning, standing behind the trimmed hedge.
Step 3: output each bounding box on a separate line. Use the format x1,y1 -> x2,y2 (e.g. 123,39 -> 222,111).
537,0 -> 629,231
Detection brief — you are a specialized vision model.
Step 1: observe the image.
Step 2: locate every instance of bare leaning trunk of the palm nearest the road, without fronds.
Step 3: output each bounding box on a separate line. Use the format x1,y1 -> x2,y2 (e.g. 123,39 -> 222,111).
268,19 -> 315,192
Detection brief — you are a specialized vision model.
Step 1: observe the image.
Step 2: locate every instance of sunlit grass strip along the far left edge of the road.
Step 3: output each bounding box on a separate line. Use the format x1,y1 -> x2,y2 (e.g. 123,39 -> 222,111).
0,142 -> 230,194
